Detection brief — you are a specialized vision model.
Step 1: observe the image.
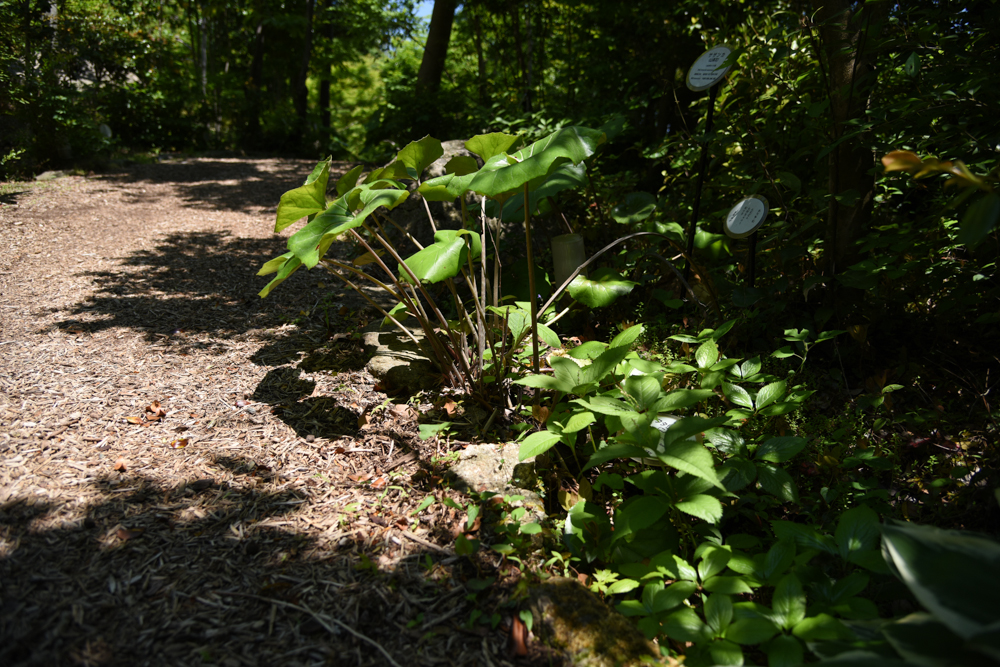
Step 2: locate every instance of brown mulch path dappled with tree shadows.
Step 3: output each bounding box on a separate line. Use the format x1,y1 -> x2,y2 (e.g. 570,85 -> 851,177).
0,157 -> 540,666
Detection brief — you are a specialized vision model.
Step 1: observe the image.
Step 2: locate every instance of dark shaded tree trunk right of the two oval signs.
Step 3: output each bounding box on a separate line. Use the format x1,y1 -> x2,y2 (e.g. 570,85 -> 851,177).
813,0 -> 888,275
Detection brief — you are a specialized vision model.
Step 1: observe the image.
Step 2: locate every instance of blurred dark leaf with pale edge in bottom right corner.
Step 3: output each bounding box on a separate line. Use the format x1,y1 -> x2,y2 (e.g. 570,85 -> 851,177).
882,521 -> 1000,639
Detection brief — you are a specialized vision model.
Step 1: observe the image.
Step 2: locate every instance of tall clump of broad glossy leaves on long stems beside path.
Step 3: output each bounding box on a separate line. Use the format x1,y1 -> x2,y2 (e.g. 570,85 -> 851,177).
259,127 -> 620,407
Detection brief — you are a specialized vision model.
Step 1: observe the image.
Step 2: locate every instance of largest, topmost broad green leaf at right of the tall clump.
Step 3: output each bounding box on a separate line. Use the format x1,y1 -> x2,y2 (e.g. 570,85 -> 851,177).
469,127 -> 605,198
